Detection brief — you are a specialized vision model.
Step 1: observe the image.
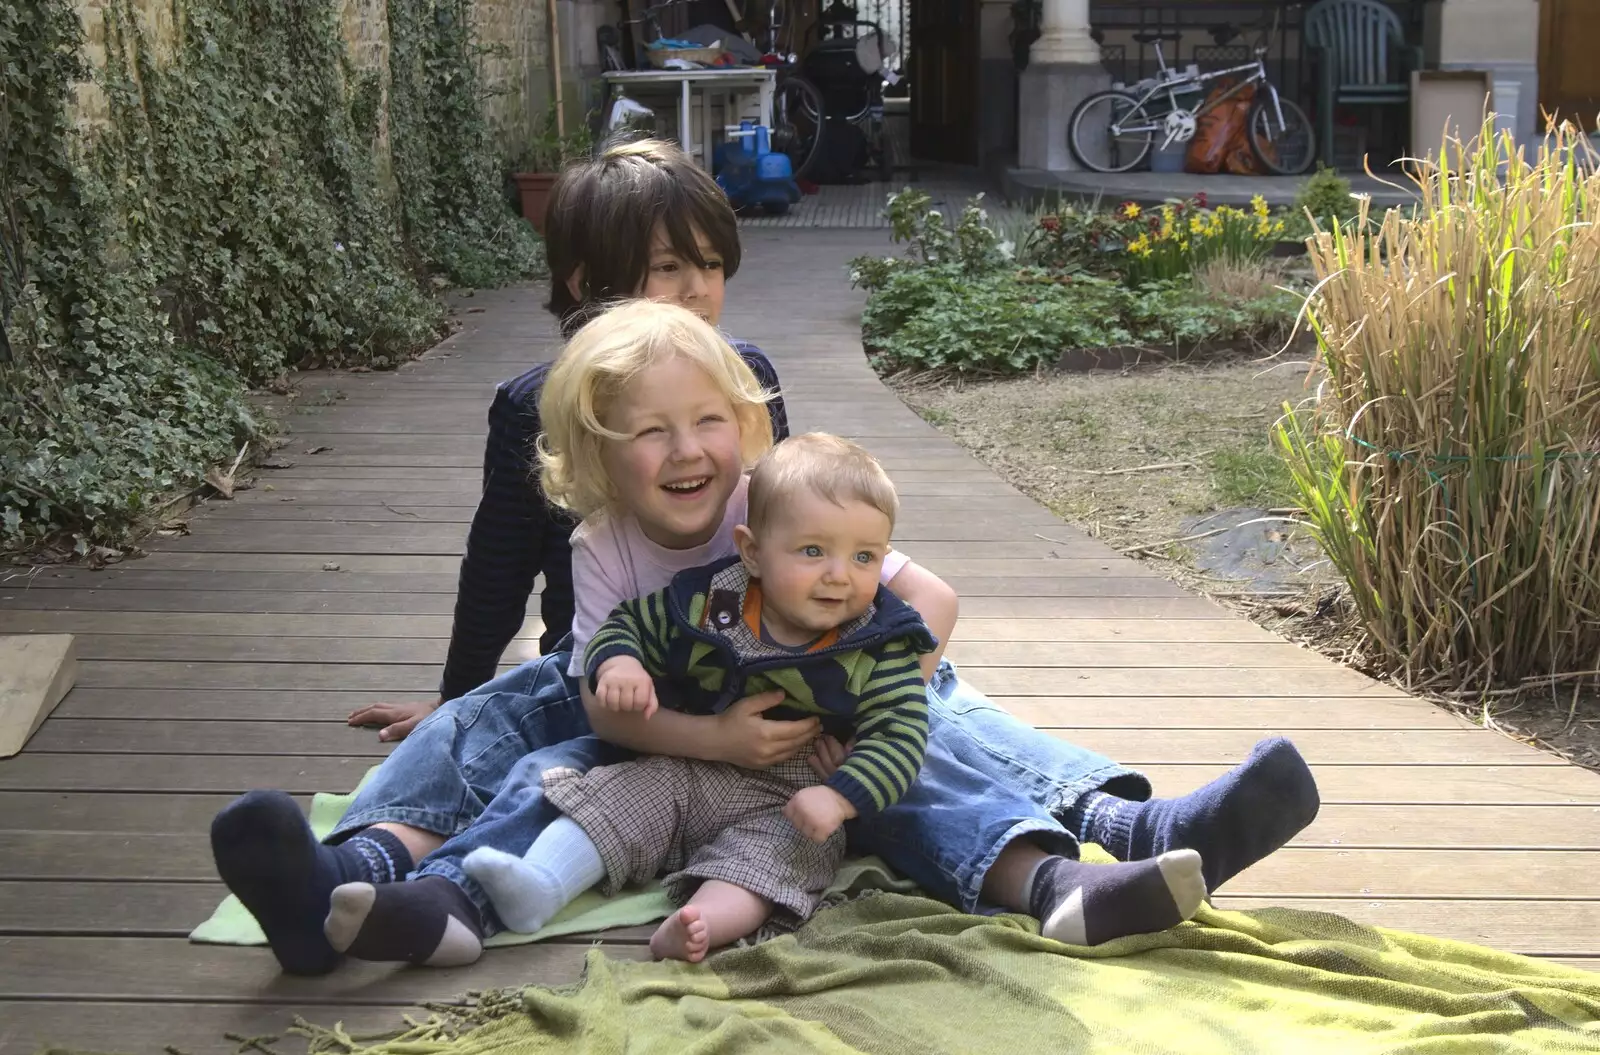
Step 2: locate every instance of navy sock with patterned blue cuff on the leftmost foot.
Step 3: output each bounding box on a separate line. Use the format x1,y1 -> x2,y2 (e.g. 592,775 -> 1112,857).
211,791 -> 413,975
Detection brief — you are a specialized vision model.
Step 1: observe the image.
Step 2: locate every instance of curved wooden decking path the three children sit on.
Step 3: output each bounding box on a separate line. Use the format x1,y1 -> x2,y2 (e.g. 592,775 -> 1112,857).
0,231 -> 1600,1055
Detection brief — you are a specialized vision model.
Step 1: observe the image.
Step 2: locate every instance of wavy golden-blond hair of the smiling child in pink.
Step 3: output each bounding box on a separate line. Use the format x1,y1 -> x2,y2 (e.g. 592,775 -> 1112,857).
538,301 -> 773,517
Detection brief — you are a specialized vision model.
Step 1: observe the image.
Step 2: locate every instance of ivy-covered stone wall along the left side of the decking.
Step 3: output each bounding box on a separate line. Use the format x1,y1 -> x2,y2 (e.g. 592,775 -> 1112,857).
0,0 -> 541,551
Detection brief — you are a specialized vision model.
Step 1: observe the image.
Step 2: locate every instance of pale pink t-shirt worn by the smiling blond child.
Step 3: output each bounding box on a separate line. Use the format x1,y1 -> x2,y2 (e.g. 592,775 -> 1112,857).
566,477 -> 910,677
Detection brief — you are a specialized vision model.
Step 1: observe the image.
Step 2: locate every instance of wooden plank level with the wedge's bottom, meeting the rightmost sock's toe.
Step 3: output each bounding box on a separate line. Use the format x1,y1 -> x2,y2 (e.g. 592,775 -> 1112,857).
29,714 -> 1548,768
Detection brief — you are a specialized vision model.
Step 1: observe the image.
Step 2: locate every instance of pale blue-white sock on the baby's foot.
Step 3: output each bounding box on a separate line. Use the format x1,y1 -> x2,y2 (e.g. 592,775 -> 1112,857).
461,816 -> 605,933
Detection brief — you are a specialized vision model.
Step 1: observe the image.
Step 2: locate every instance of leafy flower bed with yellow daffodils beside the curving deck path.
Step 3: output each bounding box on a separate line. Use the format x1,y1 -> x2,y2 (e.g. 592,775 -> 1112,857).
851,191 -> 1301,373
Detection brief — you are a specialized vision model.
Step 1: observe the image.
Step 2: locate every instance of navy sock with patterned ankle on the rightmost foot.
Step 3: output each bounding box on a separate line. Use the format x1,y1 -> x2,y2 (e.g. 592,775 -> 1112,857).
1066,736 -> 1322,893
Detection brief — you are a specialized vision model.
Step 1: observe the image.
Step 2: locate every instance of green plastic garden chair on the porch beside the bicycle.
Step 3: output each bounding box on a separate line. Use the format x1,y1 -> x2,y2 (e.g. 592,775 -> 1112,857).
1301,0 -> 1422,165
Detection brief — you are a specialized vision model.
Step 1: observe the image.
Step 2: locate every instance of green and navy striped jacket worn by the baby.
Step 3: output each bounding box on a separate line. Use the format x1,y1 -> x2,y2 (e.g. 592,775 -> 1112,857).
584,557 -> 936,816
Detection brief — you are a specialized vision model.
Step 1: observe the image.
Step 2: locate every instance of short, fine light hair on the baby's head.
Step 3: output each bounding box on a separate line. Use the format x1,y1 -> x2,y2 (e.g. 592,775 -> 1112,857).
746,432 -> 899,538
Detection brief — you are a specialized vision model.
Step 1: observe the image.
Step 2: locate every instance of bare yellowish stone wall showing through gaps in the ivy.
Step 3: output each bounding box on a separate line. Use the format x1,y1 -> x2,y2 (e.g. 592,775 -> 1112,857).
68,0 -> 550,168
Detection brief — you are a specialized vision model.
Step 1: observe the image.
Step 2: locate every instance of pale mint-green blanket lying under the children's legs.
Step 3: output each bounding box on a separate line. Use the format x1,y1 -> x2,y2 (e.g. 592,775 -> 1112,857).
189,767 -> 915,948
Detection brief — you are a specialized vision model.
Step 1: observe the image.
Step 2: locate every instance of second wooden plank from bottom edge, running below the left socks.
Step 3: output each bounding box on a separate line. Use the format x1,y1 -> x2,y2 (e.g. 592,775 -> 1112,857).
0,937 -> 636,1005
